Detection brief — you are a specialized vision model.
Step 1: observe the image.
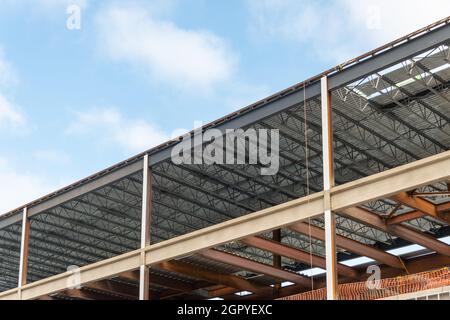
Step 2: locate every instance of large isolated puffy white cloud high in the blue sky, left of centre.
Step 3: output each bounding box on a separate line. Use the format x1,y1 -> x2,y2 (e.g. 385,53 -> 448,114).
97,5 -> 235,90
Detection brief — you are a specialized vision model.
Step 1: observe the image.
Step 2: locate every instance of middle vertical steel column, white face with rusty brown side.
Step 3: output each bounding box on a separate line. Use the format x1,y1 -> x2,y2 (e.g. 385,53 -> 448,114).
139,154 -> 152,300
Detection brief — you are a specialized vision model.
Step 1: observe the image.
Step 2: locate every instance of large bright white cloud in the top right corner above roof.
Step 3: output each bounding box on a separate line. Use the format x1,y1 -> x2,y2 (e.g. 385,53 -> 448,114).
248,0 -> 450,63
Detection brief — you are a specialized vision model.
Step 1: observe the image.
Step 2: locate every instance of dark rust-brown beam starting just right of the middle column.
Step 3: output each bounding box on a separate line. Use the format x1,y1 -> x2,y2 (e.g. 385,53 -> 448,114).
159,261 -> 273,296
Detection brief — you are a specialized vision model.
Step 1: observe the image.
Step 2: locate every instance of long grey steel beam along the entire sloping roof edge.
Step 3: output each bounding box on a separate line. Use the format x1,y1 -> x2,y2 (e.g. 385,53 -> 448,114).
0,21 -> 450,238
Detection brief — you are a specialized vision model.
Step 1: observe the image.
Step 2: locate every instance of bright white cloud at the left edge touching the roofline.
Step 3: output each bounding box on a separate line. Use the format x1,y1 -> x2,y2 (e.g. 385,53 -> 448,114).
0,158 -> 59,215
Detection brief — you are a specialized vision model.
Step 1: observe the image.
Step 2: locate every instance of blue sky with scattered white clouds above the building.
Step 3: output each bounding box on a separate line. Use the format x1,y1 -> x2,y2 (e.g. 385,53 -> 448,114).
0,0 -> 450,212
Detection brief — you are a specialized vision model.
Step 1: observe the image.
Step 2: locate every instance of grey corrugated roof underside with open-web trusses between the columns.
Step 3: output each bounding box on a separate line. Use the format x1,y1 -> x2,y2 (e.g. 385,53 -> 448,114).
0,22 -> 450,291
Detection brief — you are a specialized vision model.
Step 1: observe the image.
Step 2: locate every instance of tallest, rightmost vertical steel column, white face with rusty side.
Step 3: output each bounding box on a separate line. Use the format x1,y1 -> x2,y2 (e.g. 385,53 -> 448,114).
321,76 -> 338,300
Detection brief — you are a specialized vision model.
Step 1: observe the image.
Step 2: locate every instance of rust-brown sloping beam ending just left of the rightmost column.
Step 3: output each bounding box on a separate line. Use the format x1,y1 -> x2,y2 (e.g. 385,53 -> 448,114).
200,249 -> 311,287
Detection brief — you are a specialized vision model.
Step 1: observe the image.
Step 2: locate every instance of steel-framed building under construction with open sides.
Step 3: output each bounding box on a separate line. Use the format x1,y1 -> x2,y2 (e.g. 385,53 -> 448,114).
0,17 -> 450,300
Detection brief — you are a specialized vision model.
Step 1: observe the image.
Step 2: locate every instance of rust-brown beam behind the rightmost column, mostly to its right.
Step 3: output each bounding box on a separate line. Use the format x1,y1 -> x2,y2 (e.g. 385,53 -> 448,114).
289,222 -> 403,269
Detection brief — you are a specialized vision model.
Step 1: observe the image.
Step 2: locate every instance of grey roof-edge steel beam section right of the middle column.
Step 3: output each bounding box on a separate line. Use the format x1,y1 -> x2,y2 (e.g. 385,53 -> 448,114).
150,22 -> 450,165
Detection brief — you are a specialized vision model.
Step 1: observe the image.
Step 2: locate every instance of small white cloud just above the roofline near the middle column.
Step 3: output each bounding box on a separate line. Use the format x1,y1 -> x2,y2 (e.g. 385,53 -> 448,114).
66,108 -> 170,152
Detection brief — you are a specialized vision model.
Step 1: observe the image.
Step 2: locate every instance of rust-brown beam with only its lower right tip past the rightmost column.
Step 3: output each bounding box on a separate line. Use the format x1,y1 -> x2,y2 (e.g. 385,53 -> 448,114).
242,237 -> 359,279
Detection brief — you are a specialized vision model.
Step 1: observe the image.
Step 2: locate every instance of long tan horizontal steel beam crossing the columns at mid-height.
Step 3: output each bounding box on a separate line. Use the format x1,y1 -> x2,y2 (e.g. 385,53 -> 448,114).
0,151 -> 450,299
